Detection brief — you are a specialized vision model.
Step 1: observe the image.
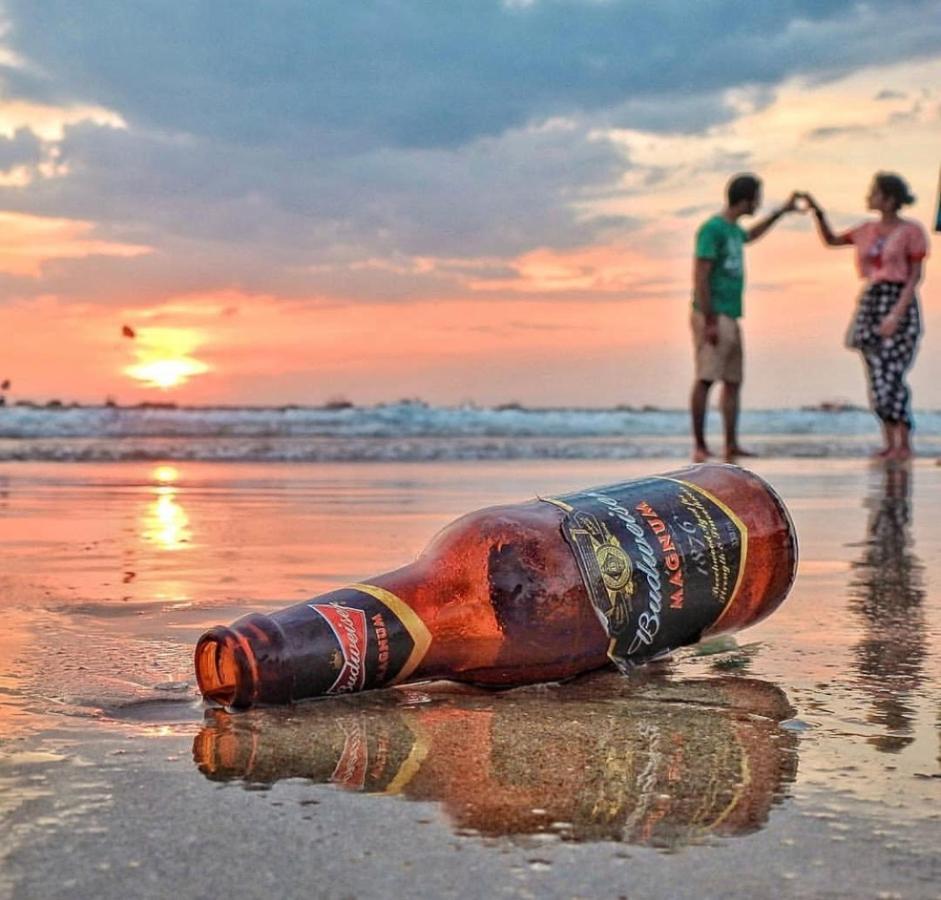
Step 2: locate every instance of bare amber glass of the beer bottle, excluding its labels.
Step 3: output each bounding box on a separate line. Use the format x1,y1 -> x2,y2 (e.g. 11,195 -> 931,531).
196,465 -> 797,707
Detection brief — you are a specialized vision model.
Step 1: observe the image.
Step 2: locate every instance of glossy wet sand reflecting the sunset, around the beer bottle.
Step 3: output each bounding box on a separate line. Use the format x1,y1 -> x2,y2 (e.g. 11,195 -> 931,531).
0,460 -> 941,898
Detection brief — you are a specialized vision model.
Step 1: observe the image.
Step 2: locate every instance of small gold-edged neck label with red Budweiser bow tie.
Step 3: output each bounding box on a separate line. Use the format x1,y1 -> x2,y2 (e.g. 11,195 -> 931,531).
307,584 -> 431,694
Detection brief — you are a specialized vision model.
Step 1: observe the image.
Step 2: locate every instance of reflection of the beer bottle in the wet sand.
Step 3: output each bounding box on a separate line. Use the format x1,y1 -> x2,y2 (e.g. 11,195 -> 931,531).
193,674 -> 797,848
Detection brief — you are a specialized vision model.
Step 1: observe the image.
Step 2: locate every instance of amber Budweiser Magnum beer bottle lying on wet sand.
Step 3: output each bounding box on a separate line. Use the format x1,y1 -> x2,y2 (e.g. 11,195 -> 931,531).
195,464 -> 797,708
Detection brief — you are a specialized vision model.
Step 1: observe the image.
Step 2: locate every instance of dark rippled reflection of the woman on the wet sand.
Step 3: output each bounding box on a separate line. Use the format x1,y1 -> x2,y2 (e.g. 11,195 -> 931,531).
849,468 -> 927,753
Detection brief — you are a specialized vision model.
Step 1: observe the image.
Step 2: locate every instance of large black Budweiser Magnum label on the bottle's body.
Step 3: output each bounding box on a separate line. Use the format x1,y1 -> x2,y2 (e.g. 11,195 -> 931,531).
547,477 -> 748,672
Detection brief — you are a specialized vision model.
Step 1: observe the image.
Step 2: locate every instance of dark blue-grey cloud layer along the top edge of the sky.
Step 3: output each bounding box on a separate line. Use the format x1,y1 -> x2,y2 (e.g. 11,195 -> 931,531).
6,0 -> 941,154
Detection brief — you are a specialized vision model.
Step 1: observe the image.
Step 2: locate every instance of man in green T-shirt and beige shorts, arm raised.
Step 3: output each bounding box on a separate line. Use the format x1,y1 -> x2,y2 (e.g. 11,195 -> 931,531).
690,174 -> 798,462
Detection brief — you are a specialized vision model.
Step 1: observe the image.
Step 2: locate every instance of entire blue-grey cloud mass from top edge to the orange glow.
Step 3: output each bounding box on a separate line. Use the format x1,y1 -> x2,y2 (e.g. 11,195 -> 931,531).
0,0 -> 941,302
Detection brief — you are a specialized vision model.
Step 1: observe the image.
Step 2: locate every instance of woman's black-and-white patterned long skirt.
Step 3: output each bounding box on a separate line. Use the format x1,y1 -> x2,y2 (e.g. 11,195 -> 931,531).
849,281 -> 921,428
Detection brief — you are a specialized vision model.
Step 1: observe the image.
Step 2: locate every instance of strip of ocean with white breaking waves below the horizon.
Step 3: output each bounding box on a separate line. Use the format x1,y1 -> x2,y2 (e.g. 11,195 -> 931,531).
0,401 -> 941,462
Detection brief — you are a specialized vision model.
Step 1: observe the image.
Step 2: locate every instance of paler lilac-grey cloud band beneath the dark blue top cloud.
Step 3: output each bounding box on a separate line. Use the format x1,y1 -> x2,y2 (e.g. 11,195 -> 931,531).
0,115 -> 638,295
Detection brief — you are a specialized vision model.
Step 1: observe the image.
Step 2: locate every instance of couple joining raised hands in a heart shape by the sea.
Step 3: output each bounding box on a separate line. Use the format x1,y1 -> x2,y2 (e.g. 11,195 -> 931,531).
690,172 -> 928,462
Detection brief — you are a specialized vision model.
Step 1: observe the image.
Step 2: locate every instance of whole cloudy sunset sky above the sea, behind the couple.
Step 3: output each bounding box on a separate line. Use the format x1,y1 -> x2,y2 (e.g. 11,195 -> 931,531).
0,0 -> 941,408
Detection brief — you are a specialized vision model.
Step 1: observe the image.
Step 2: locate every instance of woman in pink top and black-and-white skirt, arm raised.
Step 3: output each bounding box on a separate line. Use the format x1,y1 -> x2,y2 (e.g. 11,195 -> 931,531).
804,172 -> 928,461
